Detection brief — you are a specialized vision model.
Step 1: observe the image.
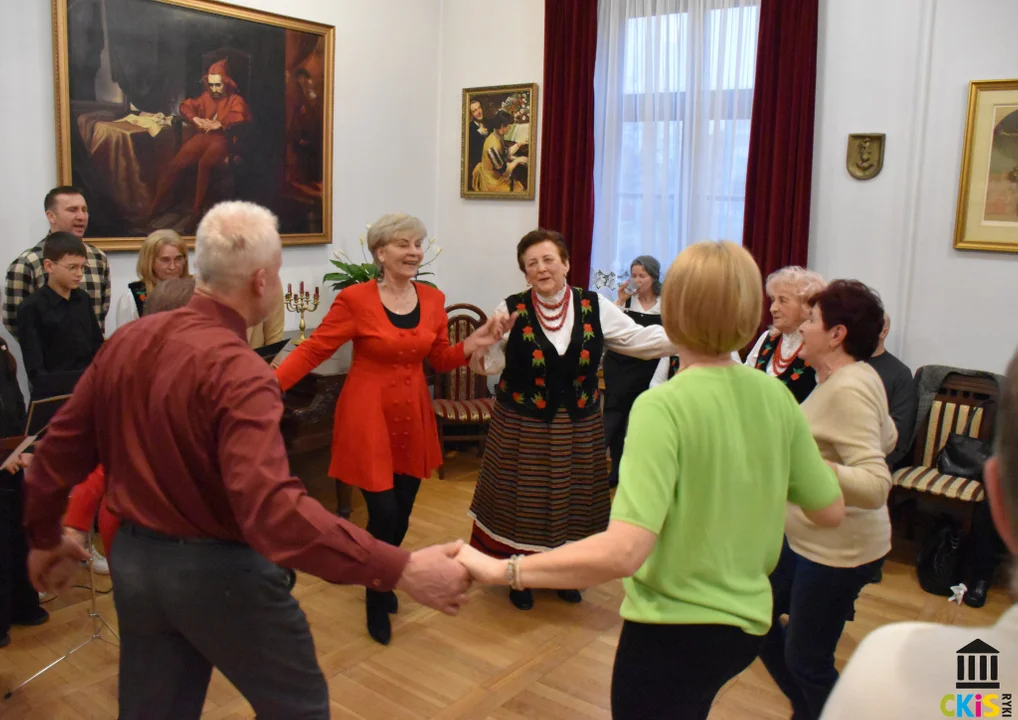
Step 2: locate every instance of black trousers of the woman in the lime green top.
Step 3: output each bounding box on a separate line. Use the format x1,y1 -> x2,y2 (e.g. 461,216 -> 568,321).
612,620 -> 764,720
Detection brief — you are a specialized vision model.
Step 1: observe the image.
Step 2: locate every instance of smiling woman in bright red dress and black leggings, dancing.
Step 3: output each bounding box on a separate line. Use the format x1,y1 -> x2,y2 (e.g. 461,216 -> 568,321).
276,213 -> 499,645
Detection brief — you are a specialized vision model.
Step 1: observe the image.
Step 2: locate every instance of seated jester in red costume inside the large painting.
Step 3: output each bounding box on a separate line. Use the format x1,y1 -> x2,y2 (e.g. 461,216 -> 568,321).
151,59 -> 251,222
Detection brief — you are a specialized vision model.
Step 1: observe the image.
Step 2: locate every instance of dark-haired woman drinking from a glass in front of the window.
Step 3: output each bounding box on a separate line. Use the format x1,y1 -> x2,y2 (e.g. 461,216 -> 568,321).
604,255 -> 661,488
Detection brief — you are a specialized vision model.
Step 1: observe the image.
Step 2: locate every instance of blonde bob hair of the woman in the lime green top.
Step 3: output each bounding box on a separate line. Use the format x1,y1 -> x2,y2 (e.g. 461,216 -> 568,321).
661,240 -> 764,355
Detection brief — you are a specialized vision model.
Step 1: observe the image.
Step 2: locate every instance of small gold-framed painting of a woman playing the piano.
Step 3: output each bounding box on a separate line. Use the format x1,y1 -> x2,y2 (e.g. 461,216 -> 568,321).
459,82 -> 538,200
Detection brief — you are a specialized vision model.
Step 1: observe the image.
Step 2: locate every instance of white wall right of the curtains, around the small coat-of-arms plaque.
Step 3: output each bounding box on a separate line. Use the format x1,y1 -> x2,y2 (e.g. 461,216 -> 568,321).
809,0 -> 1018,372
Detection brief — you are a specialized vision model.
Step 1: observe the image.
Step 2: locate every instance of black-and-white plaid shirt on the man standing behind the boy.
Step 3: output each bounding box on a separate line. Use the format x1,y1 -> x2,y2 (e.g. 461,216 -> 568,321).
3,242 -> 110,337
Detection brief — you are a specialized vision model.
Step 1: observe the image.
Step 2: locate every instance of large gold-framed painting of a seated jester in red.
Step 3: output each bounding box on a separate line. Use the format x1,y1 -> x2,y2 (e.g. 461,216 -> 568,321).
52,0 -> 336,250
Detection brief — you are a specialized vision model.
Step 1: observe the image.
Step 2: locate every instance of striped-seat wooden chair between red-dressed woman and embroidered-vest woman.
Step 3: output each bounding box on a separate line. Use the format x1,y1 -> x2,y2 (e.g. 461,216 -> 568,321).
432,304 -> 495,478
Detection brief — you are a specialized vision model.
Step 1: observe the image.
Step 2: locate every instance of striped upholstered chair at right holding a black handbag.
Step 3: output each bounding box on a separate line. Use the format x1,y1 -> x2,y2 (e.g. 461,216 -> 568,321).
893,375 -> 997,515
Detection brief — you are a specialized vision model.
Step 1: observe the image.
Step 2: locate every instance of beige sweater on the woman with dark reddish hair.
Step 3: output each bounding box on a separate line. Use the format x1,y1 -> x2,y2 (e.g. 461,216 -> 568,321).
785,363 -> 898,567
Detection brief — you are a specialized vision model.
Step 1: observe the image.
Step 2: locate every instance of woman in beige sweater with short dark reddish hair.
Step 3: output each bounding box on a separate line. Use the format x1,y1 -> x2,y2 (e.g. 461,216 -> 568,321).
760,280 -> 898,720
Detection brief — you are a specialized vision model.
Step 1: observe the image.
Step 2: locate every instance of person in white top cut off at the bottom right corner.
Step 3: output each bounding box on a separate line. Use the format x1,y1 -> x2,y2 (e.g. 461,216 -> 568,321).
821,353 -> 1018,720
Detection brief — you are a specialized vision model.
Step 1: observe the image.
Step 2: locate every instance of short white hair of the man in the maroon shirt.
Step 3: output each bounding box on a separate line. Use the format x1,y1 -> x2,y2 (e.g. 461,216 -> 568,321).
194,201 -> 283,292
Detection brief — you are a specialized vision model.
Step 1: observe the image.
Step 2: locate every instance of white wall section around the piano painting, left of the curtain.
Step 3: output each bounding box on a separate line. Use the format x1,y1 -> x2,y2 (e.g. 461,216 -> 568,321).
433,0 -> 545,313
